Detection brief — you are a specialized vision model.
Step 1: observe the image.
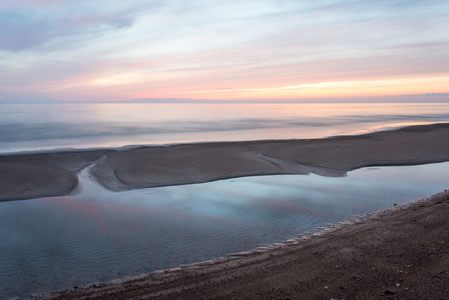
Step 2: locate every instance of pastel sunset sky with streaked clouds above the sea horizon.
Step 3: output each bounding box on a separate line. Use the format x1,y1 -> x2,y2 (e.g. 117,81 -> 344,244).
0,0 -> 449,102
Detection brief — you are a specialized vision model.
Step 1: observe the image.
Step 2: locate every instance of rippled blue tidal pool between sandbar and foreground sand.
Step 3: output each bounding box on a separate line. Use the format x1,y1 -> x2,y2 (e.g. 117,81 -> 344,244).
0,163 -> 449,298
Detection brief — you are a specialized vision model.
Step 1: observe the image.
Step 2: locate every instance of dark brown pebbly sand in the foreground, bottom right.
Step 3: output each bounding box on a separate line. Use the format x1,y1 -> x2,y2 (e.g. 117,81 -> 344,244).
37,190 -> 449,299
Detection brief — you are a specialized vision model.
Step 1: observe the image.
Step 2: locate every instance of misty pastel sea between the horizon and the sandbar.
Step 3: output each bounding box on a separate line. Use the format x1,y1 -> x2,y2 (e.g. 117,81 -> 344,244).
0,103 -> 449,153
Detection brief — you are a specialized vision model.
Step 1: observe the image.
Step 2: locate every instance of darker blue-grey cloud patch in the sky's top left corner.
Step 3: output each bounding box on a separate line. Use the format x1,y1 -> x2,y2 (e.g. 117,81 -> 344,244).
0,1 -> 143,52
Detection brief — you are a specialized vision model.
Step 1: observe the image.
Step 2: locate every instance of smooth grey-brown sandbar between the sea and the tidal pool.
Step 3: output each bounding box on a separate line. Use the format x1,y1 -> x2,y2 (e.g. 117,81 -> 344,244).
0,123 -> 449,201
